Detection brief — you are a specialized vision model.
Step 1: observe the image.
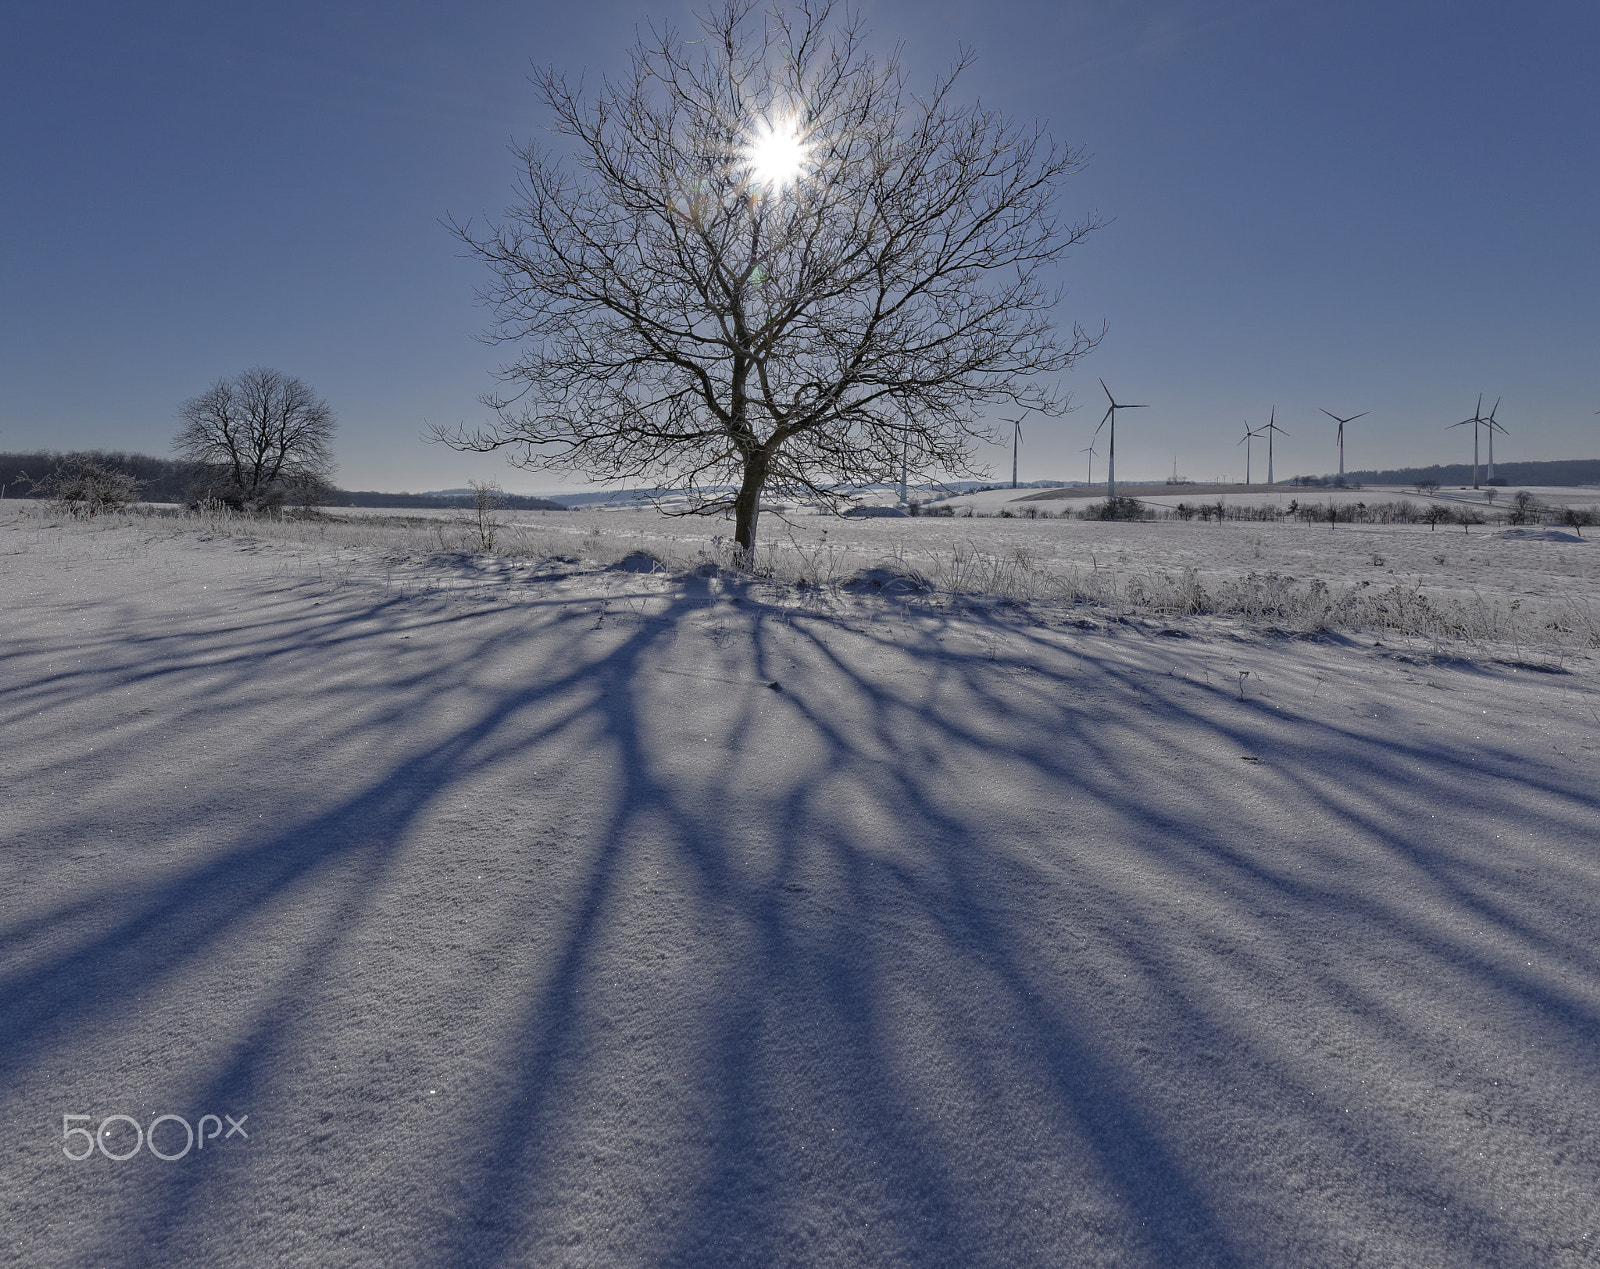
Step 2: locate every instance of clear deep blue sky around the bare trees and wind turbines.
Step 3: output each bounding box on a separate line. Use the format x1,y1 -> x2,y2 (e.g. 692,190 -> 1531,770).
0,0 -> 1600,491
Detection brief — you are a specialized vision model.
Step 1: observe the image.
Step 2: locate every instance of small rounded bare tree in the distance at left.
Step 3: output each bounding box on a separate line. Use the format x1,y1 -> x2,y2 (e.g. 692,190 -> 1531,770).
173,366 -> 336,510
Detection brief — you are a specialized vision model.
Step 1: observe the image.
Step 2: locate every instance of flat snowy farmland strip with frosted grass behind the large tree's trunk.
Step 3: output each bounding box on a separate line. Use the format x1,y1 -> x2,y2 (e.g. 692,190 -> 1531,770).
350,490 -> 1600,661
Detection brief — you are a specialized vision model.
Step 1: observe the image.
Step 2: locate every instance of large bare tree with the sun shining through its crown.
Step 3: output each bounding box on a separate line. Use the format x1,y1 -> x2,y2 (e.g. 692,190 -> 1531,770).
434,0 -> 1098,550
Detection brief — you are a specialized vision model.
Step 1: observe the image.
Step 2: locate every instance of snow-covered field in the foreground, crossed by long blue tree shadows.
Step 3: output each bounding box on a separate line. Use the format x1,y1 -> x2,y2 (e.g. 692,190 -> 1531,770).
9,506 -> 1600,1269
